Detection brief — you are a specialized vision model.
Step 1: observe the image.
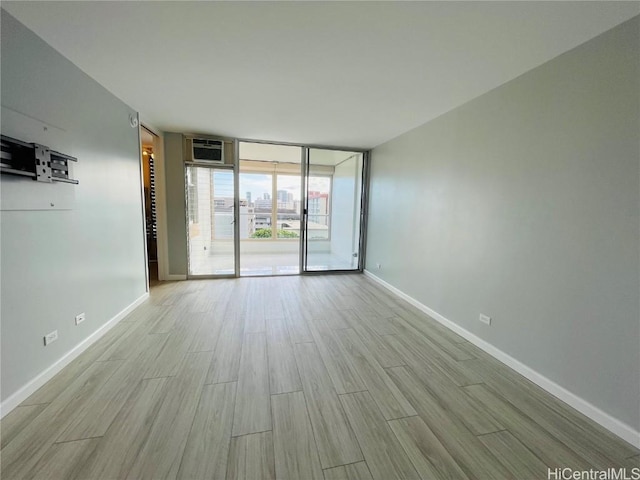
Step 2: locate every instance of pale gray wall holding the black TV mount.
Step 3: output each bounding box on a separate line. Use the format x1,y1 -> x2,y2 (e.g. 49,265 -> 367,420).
0,11 -> 146,401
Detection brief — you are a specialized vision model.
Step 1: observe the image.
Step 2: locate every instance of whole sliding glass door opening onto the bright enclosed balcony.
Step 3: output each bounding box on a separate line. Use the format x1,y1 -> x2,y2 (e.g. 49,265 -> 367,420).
185,142 -> 365,278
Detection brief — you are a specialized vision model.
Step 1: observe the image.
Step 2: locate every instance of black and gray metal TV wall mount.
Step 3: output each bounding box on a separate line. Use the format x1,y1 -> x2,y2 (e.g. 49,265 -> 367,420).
0,135 -> 79,185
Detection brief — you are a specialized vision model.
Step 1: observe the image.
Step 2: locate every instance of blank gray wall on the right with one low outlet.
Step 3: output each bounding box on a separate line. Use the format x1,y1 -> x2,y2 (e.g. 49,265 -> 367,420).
367,17 -> 640,430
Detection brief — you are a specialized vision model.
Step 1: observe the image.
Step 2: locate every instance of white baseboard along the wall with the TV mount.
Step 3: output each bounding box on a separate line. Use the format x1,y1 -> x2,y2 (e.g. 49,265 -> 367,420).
0,293 -> 149,418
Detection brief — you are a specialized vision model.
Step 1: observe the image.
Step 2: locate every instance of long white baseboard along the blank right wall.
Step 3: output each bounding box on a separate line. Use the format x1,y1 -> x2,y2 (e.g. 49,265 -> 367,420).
364,270 -> 640,448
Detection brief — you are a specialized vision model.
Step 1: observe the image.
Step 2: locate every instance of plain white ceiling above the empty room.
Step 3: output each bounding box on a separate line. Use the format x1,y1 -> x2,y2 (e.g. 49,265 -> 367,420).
2,1 -> 640,148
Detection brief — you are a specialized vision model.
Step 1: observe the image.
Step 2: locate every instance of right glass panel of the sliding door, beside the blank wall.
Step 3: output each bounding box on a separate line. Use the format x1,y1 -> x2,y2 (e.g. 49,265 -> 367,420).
303,148 -> 364,271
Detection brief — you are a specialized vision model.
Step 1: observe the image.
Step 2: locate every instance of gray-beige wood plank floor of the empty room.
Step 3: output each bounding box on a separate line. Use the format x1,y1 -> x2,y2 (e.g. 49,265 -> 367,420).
0,275 -> 640,480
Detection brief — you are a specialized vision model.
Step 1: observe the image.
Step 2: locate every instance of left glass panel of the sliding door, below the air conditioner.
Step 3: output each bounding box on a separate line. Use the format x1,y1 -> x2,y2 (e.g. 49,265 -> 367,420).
186,165 -> 235,276
